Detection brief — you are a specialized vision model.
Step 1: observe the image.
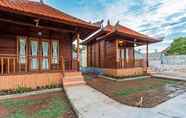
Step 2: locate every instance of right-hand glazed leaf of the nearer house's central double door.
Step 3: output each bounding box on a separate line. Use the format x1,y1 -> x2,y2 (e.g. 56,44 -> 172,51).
42,41 -> 49,70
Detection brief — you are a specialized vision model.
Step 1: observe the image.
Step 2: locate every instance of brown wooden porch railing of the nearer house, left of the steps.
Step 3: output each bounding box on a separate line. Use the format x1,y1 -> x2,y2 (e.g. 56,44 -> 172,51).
0,54 -> 65,75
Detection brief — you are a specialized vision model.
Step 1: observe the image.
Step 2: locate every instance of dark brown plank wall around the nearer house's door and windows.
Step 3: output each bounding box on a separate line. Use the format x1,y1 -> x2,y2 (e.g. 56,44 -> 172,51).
0,22 -> 72,71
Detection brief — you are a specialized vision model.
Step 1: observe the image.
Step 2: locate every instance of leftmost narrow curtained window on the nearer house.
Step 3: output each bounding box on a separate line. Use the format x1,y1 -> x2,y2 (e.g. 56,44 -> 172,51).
19,37 -> 26,64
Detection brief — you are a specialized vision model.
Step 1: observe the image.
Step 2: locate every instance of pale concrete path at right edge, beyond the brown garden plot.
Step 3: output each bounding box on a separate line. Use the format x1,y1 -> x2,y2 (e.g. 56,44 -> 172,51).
152,72 -> 186,81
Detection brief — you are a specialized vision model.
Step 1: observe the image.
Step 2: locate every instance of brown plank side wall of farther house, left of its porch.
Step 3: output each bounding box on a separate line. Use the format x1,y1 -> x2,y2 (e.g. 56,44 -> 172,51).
87,40 -> 116,68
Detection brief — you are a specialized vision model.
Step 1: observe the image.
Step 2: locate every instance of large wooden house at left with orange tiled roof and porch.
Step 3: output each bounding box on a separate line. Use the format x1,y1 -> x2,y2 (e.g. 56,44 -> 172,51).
0,0 -> 100,90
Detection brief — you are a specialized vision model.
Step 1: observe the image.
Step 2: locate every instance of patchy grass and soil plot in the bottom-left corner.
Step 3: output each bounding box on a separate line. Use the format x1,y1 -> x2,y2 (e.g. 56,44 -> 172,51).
0,92 -> 75,118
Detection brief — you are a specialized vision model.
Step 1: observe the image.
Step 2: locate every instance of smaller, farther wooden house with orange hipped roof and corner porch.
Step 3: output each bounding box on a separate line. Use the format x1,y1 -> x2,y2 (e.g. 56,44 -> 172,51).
83,22 -> 160,77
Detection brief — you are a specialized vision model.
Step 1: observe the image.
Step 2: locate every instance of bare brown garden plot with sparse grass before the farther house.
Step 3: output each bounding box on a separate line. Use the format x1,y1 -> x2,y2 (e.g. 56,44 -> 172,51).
85,75 -> 186,108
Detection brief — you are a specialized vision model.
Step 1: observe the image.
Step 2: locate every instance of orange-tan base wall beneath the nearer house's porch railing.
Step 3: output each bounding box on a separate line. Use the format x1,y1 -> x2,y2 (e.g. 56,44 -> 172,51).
0,73 -> 62,91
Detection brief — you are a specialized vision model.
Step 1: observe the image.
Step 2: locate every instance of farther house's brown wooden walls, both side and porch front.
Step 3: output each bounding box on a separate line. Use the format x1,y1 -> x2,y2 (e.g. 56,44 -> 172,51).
87,40 -> 135,68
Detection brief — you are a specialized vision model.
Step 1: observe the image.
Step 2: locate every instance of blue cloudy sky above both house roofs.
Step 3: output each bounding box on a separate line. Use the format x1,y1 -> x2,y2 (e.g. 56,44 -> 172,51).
32,0 -> 186,52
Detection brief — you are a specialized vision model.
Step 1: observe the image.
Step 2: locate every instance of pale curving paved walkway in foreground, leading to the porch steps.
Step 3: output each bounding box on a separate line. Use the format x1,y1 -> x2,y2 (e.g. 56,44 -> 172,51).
65,85 -> 186,118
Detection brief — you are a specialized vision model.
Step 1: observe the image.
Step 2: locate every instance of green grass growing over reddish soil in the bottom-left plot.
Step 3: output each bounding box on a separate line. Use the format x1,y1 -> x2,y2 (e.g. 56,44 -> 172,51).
0,93 -> 70,118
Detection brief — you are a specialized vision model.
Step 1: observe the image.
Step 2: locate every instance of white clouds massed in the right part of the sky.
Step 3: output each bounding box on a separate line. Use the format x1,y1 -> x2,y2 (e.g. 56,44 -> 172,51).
96,0 -> 186,51
